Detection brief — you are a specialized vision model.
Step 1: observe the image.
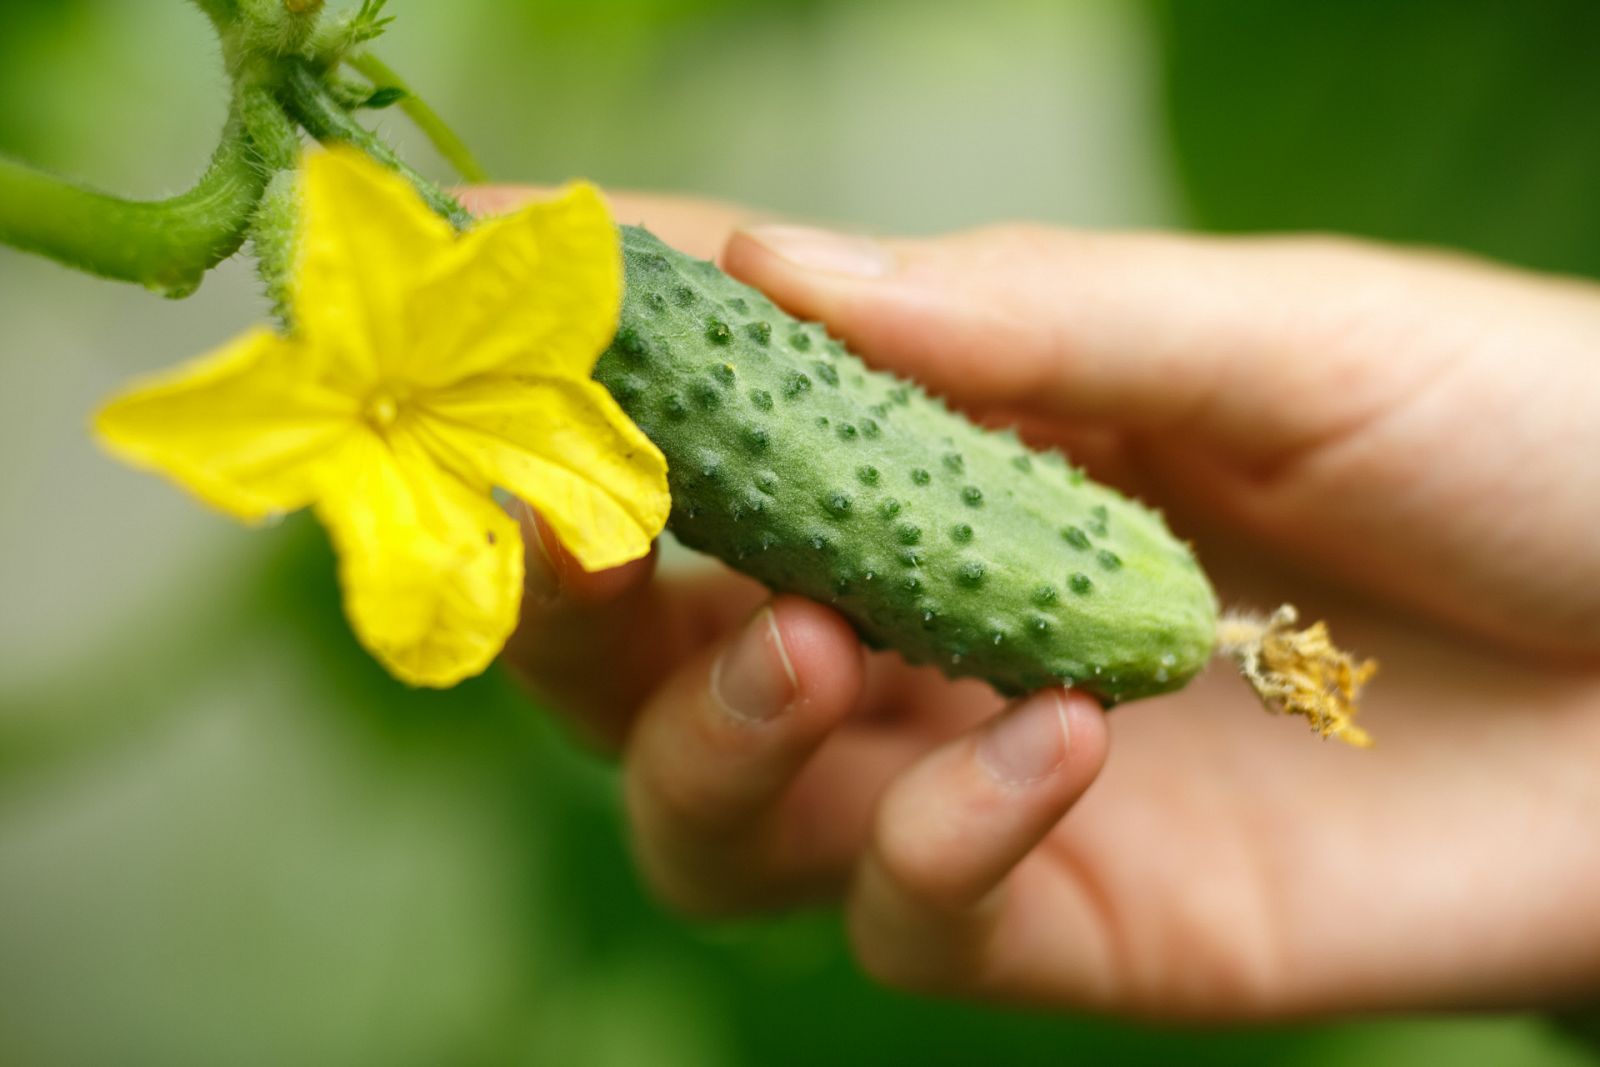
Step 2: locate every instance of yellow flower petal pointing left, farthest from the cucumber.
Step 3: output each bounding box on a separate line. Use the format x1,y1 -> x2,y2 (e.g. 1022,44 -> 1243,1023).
94,330 -> 355,522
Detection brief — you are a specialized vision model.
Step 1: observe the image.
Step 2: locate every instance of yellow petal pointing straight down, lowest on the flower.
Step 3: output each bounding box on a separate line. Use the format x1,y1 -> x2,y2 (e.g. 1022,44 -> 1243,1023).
317,434 -> 522,688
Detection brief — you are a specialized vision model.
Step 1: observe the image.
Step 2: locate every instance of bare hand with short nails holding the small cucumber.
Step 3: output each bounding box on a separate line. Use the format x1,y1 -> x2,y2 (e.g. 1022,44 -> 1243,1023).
460,190 -> 1600,1021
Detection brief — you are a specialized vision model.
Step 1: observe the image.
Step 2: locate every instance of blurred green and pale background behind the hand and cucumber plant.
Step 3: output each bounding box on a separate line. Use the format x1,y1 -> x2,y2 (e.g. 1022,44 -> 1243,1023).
0,0 -> 1600,1067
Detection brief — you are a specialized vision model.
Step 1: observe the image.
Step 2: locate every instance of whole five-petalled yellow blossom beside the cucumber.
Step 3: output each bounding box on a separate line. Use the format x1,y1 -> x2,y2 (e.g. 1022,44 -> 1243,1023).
96,150 -> 669,686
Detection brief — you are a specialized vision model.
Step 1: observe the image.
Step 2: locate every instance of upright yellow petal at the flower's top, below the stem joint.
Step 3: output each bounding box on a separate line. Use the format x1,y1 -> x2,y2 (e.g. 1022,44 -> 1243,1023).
290,149 -> 456,385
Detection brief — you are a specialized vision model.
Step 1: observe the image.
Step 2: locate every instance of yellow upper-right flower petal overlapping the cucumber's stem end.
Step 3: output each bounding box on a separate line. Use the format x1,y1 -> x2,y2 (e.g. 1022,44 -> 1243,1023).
408,182 -> 622,386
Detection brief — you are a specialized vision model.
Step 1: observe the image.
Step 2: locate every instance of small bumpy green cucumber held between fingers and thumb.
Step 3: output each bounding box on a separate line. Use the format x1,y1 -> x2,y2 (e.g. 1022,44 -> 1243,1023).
595,227 -> 1216,702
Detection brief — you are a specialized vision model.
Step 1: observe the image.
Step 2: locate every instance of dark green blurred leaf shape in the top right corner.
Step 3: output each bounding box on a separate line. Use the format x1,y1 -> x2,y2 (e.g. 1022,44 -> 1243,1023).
1155,0 -> 1600,277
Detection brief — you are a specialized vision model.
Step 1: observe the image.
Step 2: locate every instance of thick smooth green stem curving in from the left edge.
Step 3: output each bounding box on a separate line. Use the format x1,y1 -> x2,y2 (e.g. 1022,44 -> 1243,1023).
0,90 -> 281,296
